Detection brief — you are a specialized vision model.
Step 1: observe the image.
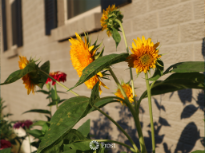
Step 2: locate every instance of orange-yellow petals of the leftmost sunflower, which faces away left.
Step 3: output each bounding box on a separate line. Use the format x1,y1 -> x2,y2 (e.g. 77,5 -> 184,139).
19,56 -> 35,95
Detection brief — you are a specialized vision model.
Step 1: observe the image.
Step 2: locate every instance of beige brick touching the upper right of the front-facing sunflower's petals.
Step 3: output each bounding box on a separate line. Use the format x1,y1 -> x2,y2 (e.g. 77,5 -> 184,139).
148,26 -> 179,46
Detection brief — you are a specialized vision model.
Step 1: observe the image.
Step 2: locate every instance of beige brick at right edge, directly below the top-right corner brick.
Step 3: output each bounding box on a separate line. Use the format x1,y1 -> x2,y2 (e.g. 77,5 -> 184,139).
180,20 -> 204,42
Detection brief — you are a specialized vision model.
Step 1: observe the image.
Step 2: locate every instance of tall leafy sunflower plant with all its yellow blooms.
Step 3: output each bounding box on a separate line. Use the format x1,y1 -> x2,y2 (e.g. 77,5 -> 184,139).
1,5 -> 204,153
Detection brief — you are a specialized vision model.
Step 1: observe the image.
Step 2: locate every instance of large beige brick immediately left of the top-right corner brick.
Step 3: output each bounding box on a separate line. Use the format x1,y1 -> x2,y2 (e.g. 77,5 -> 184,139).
159,2 -> 193,26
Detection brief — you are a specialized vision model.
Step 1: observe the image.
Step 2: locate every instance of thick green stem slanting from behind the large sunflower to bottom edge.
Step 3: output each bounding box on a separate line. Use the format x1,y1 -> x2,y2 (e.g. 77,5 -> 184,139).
109,68 -> 147,153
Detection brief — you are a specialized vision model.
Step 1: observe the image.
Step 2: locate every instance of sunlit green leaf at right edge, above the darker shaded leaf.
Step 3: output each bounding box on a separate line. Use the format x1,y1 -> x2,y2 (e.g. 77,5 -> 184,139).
164,61 -> 205,74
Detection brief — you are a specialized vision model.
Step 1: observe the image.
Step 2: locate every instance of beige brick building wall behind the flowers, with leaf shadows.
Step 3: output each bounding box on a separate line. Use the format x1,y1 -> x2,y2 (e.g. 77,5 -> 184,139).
1,0 -> 204,153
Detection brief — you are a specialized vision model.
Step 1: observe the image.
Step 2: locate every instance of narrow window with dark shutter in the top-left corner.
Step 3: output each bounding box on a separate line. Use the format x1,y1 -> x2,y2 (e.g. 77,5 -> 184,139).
1,0 -> 23,52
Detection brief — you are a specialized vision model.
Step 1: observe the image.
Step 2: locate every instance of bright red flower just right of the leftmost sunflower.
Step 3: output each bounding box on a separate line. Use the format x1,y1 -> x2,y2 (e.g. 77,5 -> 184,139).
46,71 -> 67,85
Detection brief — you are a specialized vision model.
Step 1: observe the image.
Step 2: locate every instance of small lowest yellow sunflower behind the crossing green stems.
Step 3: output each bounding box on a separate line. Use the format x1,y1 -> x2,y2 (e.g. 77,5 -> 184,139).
115,83 -> 136,105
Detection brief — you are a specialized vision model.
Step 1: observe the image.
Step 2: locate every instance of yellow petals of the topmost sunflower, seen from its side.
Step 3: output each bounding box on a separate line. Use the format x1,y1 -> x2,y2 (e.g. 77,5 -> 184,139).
100,5 -> 117,37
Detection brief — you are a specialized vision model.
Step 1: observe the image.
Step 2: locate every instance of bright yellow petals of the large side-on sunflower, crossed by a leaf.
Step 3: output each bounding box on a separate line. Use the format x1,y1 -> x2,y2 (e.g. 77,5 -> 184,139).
69,33 -> 108,93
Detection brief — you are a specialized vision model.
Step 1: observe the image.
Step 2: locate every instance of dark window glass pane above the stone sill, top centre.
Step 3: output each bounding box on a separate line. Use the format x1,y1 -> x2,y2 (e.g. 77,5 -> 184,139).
67,0 -> 100,19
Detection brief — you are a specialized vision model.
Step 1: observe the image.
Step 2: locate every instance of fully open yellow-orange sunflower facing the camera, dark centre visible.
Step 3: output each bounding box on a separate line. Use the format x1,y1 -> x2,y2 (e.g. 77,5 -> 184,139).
127,36 -> 161,74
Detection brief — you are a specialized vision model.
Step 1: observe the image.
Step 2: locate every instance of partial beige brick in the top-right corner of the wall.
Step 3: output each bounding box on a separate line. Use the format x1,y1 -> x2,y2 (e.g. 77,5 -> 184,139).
193,0 -> 204,19
